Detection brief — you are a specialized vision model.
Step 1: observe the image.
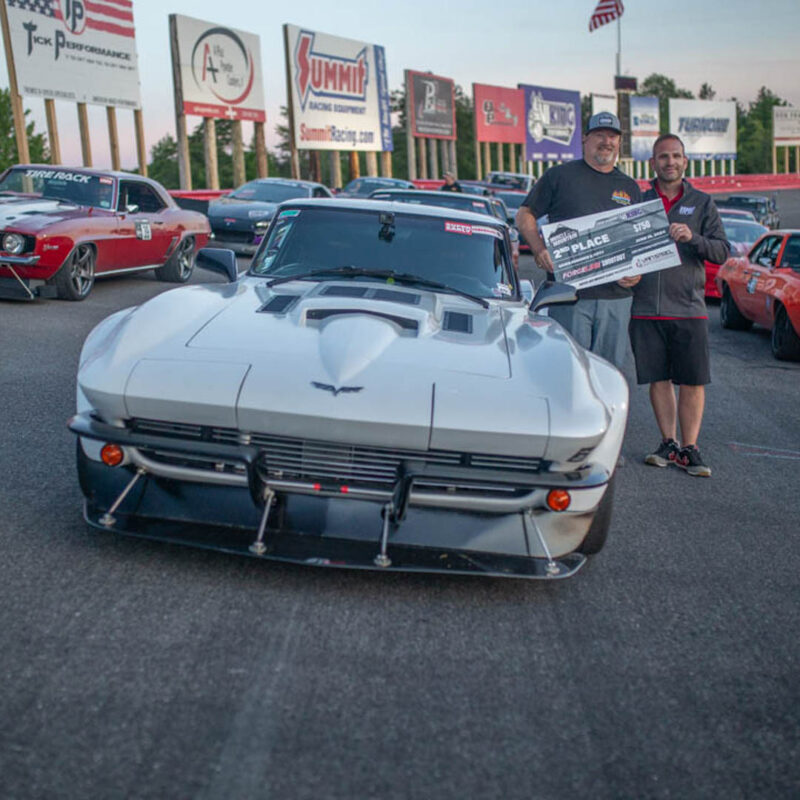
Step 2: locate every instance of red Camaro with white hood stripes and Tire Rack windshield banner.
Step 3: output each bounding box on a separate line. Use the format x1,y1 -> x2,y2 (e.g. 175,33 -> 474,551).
0,165 -> 210,300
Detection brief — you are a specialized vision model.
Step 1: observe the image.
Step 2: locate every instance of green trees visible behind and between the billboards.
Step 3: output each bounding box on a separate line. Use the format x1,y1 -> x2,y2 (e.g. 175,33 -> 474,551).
0,73 -> 788,189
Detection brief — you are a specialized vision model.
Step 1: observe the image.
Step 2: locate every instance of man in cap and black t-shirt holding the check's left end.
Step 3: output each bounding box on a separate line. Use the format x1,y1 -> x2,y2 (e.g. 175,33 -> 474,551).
517,112 -> 641,368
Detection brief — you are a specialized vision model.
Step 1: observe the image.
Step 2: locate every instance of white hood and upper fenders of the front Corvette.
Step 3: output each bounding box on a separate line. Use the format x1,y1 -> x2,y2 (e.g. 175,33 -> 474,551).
78,278 -> 609,457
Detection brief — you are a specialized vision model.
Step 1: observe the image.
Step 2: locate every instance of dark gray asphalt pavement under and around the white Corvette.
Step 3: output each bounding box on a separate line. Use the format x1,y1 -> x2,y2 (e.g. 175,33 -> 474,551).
0,192 -> 800,800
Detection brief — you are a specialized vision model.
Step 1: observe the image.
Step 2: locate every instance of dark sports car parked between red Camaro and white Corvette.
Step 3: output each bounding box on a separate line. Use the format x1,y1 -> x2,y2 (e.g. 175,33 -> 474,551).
207,178 -> 333,255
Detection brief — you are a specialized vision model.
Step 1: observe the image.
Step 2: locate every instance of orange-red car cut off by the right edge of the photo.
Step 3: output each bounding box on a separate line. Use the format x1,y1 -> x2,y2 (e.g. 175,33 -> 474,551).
716,230 -> 800,360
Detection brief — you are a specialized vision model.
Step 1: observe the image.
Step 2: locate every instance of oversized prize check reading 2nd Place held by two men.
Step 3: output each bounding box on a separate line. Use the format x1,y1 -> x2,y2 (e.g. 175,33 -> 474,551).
542,200 -> 681,289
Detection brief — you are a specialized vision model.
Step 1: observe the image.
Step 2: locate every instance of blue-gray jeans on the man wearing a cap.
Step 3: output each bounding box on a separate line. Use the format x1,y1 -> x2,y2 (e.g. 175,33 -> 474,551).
548,297 -> 633,369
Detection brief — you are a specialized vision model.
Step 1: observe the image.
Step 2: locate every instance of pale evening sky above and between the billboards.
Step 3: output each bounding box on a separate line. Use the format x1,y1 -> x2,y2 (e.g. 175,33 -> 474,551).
0,0 -> 800,167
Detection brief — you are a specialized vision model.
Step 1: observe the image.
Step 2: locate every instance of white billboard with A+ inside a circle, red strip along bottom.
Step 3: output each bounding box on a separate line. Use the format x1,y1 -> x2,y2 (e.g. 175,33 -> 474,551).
172,14 -> 267,122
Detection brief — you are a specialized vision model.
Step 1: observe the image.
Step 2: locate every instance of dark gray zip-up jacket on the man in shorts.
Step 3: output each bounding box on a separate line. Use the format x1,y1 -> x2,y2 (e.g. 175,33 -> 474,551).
631,179 -> 731,317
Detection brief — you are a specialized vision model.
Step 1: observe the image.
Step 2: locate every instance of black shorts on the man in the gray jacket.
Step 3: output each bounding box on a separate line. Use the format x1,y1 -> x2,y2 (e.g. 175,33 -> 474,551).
628,319 -> 711,386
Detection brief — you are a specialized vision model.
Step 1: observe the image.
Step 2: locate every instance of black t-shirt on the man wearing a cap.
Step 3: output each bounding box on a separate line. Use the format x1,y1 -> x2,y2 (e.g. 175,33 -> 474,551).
522,159 -> 642,300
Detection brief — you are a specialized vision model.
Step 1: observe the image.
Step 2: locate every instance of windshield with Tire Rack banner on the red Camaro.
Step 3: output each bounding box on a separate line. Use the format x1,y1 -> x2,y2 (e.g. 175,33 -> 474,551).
0,167 -> 114,209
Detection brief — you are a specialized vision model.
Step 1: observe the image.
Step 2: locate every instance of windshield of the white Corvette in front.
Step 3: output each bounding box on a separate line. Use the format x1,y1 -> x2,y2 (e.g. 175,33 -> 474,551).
251,208 -> 514,297
